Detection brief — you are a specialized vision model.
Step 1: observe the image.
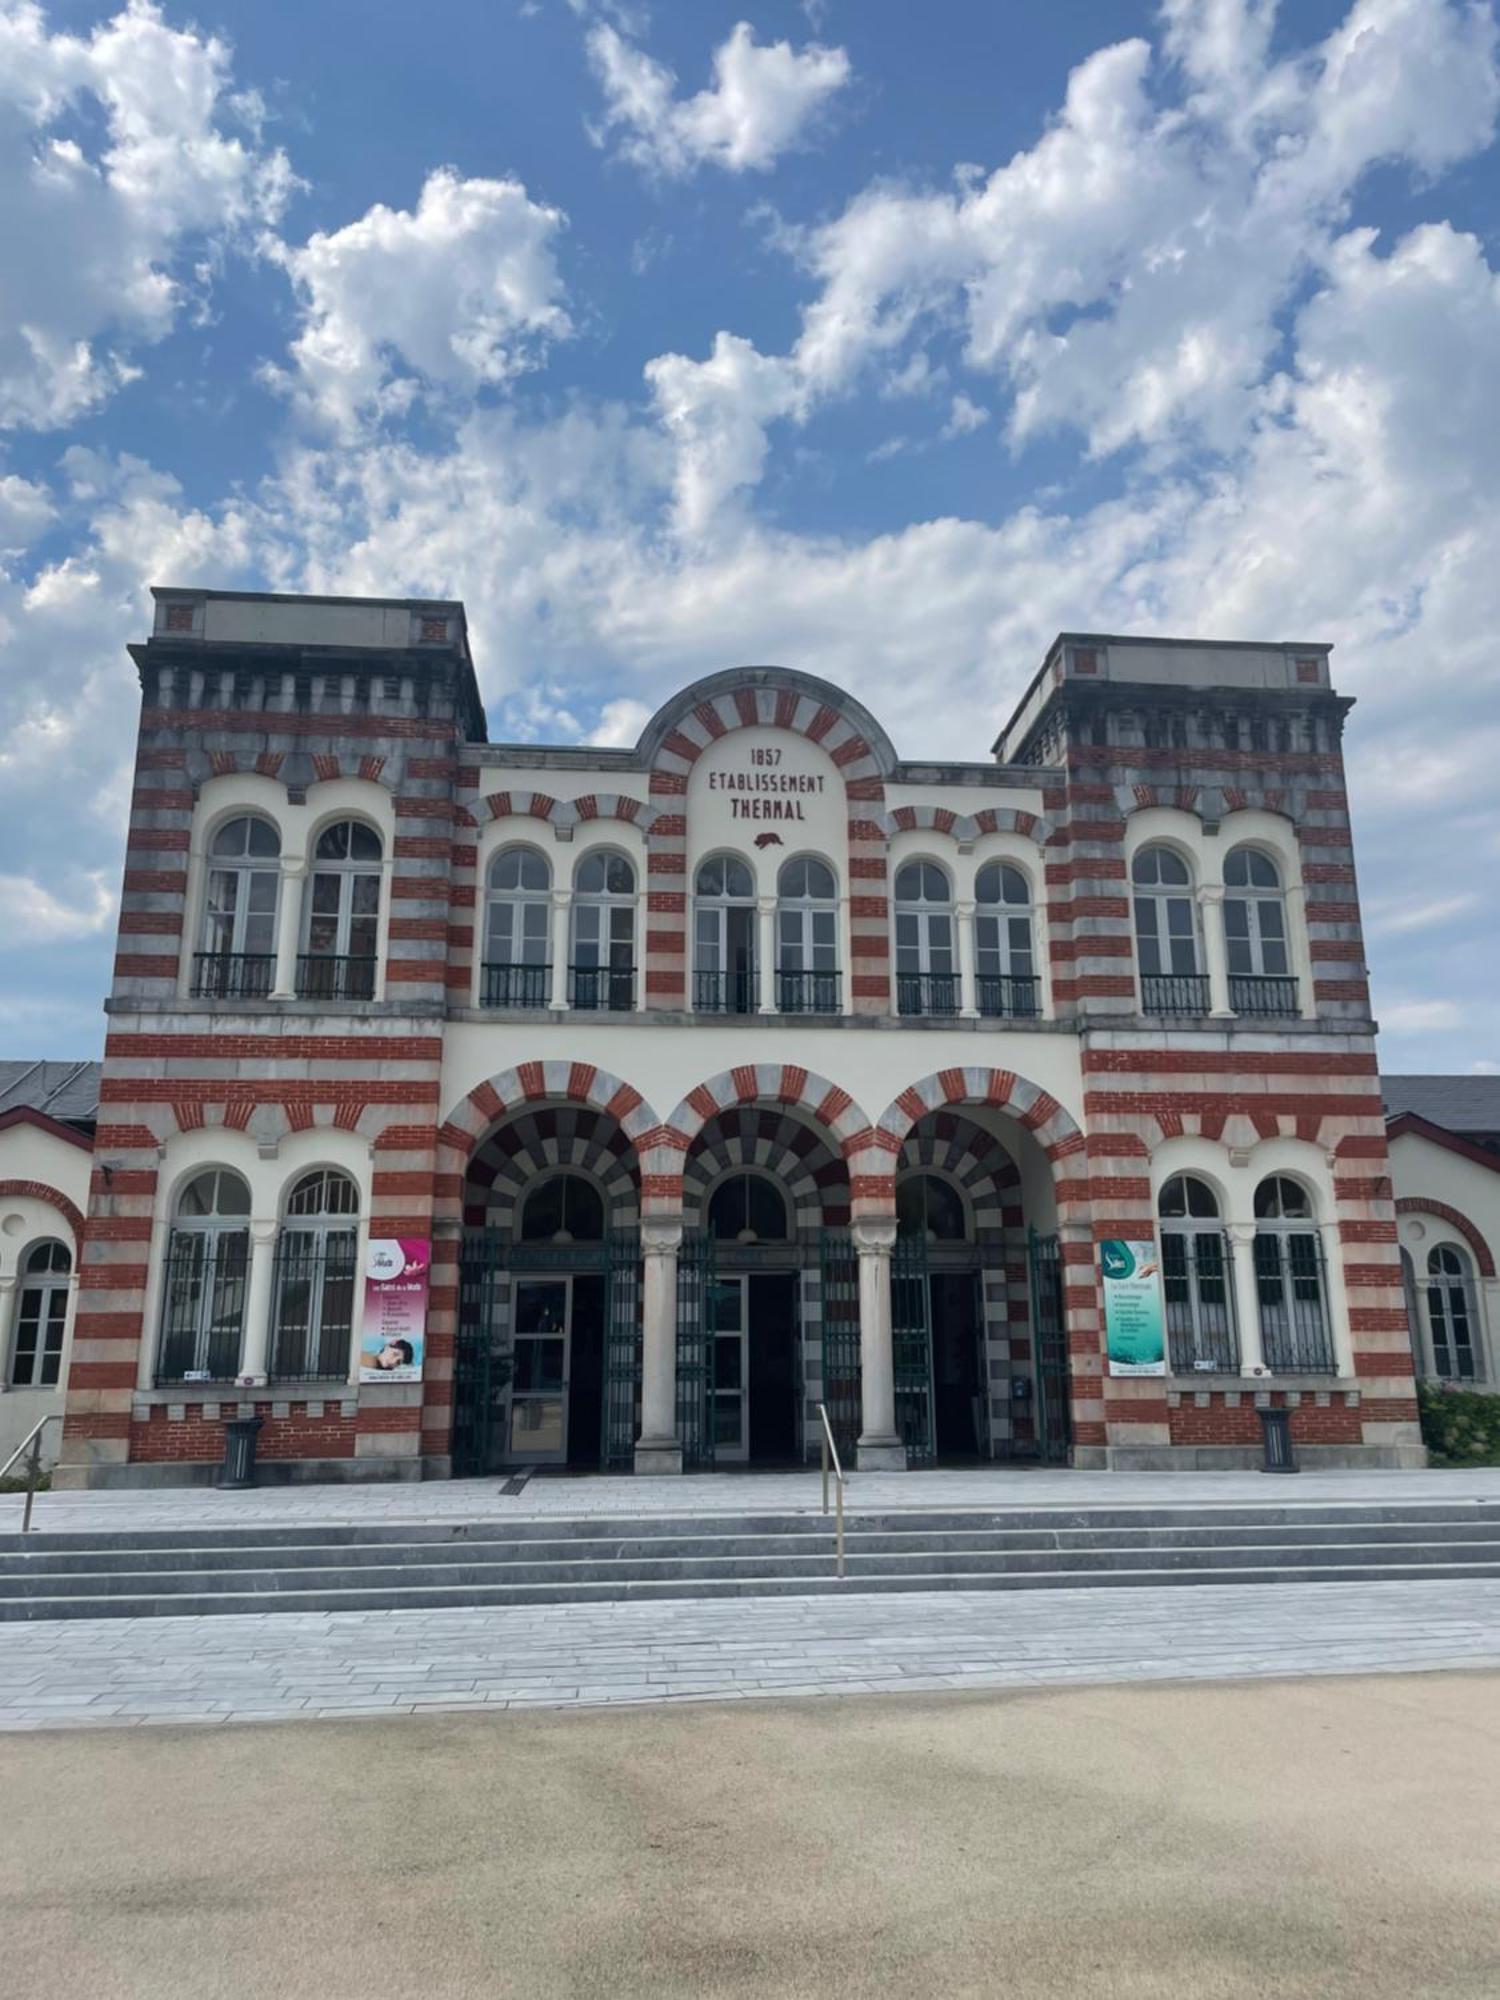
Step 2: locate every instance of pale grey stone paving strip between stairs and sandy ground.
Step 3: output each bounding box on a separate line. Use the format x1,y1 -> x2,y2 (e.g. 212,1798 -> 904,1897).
0,1580 -> 1500,1730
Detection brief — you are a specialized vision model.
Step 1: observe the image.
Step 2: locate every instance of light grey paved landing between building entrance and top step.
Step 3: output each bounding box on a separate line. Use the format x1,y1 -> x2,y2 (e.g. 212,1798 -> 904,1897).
11,1466 -> 1500,1534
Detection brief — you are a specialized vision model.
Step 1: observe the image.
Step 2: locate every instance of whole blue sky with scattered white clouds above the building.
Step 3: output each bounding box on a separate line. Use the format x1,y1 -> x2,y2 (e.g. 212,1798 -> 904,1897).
0,0 -> 1500,1068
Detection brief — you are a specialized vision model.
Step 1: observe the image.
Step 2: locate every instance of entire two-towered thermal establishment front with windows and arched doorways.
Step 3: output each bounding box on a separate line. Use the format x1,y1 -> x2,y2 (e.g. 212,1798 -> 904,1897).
58,590 -> 1422,1484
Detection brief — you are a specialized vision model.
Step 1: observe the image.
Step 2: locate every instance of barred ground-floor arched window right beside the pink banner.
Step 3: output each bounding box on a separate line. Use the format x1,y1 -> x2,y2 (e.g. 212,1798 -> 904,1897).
270,1168 -> 360,1382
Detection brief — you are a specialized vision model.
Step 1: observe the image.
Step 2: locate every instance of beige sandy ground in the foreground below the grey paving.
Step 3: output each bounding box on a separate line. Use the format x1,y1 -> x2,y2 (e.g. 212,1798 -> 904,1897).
0,1674 -> 1500,2000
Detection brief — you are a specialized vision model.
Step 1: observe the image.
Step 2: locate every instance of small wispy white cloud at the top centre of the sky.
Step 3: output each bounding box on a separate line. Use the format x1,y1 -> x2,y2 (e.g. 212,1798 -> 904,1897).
588,20 -> 850,178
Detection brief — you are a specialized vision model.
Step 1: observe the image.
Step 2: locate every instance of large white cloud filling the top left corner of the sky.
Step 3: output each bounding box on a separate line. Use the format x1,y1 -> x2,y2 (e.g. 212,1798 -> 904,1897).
0,0 -> 292,428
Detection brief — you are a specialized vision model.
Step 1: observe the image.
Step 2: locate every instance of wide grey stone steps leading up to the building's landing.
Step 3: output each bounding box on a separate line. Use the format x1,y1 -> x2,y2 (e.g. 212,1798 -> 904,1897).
0,1500 -> 1500,1620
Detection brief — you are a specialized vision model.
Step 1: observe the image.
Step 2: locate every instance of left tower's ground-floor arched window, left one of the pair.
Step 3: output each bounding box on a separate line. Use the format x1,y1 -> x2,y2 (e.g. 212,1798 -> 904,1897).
156,1166 -> 250,1382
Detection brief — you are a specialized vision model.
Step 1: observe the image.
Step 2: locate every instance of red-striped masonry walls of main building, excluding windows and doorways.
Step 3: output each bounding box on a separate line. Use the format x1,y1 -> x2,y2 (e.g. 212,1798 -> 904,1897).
60,590 -> 1420,1484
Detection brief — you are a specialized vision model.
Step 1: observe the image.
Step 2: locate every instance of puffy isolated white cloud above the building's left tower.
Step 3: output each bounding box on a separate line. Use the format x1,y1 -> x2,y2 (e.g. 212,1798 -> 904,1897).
272,168 -> 572,428
